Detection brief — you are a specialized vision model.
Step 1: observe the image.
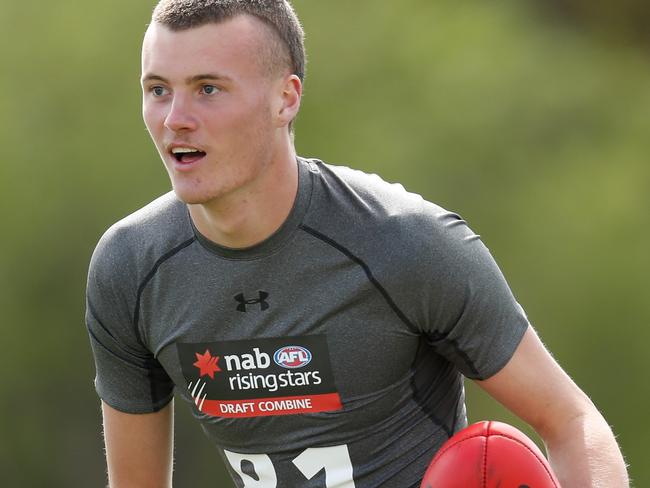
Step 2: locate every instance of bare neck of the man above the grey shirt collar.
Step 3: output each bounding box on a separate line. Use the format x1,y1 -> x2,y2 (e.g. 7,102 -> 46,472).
188,149 -> 298,248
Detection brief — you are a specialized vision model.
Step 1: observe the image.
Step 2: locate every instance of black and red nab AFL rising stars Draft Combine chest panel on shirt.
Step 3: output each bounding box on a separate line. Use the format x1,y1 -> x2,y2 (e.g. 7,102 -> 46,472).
176,338 -> 343,418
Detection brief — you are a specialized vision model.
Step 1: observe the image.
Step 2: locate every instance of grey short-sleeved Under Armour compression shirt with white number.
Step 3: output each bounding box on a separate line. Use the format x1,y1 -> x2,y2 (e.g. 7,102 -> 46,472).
86,159 -> 528,488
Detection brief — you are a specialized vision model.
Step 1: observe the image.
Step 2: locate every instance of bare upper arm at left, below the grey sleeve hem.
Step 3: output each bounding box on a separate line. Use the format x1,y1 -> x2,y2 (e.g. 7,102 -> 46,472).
102,400 -> 174,488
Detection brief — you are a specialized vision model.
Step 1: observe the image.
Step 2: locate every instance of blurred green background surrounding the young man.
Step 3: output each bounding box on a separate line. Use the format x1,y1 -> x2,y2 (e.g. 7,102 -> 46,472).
0,0 -> 650,487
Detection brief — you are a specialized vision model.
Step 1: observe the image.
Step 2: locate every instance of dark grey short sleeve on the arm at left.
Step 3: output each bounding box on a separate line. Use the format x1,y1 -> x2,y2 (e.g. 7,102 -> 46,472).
86,230 -> 173,413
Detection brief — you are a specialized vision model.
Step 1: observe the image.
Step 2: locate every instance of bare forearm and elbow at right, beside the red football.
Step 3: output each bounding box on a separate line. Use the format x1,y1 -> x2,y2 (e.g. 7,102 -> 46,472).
476,327 -> 629,488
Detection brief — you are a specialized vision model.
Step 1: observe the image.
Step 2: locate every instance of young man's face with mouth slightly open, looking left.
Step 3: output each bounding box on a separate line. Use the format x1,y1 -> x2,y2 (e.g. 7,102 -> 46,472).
142,16 -> 287,204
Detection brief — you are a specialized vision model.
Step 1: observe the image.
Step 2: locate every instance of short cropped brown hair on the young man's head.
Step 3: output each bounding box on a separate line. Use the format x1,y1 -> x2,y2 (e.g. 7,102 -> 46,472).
151,0 -> 305,81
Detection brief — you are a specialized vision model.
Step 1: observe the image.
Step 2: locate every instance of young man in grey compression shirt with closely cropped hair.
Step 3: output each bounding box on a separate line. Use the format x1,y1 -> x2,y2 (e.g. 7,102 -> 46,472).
87,0 -> 627,488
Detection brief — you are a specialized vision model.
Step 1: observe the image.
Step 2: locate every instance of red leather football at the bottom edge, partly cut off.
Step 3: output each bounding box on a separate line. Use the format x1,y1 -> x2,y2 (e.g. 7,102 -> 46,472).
420,421 -> 560,488
